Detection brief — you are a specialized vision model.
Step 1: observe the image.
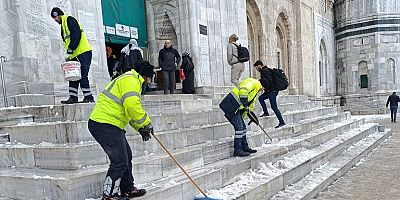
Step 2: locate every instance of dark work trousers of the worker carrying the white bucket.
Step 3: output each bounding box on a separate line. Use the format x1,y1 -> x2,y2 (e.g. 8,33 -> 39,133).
69,51 -> 93,101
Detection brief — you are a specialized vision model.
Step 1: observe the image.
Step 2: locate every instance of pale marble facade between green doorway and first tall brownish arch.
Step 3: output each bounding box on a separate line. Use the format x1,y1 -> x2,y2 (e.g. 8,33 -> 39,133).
146,0 -> 249,86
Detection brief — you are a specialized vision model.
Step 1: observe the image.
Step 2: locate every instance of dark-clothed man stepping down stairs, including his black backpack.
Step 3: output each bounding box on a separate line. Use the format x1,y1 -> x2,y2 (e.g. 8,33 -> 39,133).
254,60 -> 288,128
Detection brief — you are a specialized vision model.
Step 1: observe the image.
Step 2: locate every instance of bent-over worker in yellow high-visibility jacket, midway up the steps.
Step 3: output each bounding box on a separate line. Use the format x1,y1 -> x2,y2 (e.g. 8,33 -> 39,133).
219,78 -> 262,157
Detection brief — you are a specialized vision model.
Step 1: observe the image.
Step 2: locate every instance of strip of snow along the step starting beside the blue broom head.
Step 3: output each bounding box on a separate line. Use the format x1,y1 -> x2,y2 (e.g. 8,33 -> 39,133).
208,124 -> 376,200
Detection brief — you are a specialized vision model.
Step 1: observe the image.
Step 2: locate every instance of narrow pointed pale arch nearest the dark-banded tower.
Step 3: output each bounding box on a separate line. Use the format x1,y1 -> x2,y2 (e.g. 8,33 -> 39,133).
318,39 -> 328,96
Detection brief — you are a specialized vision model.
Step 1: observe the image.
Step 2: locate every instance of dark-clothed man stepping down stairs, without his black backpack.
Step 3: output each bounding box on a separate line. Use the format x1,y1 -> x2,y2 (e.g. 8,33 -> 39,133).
254,60 -> 286,128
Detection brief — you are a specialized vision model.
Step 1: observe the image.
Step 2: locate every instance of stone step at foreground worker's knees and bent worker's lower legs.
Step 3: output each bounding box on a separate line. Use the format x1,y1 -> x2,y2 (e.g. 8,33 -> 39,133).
0,110 -> 343,171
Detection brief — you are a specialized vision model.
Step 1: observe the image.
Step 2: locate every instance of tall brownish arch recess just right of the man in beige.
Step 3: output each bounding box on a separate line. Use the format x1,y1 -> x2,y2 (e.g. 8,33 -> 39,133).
246,0 -> 263,77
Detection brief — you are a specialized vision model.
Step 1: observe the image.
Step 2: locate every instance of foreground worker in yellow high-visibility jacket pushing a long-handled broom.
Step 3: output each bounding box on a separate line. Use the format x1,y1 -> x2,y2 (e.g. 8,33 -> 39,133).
88,61 -> 154,200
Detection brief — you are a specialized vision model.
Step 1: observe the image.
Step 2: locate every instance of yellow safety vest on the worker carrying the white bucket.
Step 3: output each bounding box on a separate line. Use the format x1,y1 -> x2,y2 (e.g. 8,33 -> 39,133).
61,15 -> 92,59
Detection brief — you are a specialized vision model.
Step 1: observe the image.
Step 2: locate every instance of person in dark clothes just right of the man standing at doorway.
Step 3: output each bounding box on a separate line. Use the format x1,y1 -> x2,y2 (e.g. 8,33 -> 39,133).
181,52 -> 195,94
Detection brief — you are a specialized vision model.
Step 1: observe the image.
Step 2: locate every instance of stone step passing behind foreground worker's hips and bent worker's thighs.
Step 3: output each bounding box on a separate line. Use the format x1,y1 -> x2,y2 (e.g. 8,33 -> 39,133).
0,107 -> 337,144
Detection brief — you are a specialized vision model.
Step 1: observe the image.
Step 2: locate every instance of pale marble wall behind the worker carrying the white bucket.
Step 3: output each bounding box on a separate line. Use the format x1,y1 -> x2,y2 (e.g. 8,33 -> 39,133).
0,0 -> 108,94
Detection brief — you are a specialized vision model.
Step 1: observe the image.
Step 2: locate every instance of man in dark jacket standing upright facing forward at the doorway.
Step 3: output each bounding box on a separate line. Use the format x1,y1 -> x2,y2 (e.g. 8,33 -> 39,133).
158,40 -> 181,94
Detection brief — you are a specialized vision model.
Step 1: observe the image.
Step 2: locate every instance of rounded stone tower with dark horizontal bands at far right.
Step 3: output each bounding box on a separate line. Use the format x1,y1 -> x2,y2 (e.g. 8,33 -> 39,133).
335,0 -> 400,113
